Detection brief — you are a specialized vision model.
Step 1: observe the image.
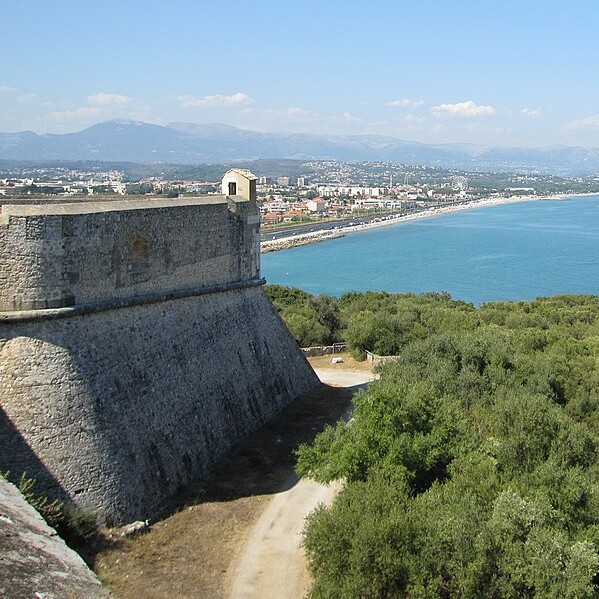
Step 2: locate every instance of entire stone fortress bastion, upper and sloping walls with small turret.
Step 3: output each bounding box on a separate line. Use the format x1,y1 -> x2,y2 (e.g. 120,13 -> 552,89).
0,178 -> 318,524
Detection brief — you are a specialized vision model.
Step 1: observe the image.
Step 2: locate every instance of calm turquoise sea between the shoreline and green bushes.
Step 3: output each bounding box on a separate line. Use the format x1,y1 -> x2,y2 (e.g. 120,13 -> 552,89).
262,196 -> 599,304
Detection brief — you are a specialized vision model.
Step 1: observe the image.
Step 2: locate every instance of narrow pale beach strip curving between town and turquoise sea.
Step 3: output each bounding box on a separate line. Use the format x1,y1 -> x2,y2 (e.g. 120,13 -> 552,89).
260,193 -> 598,254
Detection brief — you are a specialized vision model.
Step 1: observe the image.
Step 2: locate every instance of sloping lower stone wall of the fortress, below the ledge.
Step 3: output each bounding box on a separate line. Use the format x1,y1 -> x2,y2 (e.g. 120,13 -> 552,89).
0,286 -> 317,523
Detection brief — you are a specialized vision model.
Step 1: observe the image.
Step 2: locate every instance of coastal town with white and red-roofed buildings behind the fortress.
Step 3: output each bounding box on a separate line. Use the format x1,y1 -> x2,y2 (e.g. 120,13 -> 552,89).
0,160 -> 599,252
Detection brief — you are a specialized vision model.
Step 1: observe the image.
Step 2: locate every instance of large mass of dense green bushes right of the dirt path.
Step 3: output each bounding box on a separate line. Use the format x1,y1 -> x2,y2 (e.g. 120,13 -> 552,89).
282,294 -> 599,599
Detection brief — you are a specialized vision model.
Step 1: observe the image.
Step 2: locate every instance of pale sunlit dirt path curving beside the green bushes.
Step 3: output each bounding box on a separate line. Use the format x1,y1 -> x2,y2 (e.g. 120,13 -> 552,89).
229,368 -> 373,599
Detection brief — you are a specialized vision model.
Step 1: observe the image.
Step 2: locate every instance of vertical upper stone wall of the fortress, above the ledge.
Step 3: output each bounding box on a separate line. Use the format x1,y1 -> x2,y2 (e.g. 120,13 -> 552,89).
0,196 -> 259,311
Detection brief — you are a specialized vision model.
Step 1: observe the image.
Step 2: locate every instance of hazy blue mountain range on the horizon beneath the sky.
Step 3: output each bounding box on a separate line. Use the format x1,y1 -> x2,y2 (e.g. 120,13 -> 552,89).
0,120 -> 599,175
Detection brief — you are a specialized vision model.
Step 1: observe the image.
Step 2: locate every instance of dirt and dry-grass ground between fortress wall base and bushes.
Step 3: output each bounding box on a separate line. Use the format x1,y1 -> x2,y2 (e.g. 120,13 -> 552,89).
94,354 -> 371,599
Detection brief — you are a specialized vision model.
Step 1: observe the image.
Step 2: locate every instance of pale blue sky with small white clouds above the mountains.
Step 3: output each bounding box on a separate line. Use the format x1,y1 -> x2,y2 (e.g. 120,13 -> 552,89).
0,0 -> 599,147
